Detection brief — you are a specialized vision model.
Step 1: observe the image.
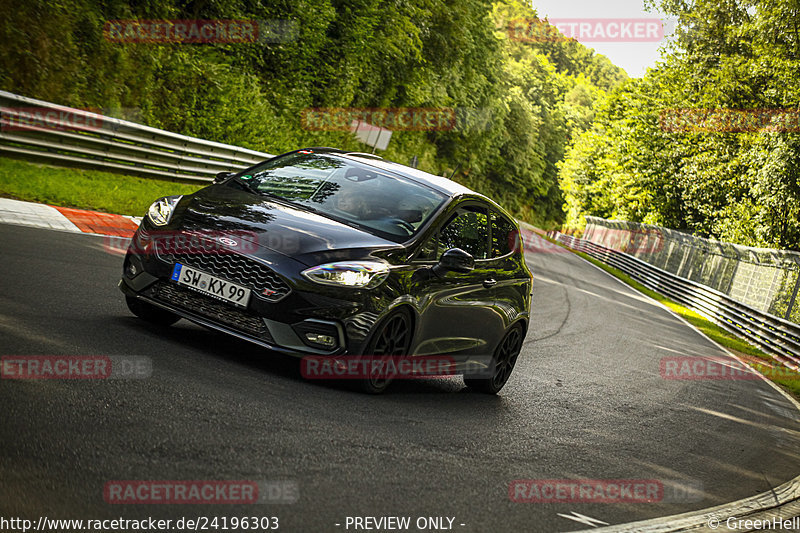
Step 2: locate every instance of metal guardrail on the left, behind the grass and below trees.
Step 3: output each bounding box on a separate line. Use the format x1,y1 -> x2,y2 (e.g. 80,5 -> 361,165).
0,91 -> 273,182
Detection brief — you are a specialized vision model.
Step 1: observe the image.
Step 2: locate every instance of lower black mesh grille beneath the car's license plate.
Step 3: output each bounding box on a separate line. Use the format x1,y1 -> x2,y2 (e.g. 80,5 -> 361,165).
150,281 -> 273,343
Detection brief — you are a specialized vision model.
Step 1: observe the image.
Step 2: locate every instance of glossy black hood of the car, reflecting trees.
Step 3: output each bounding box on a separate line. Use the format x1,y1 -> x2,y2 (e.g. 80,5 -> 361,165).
174,185 -> 403,266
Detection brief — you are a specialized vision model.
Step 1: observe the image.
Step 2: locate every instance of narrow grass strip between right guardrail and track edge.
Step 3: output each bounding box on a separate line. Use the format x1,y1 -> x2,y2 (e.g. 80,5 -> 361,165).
536,233 -> 800,400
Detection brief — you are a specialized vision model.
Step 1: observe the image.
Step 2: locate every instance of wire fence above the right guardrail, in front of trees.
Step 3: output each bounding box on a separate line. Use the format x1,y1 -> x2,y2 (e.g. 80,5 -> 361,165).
583,217 -> 800,323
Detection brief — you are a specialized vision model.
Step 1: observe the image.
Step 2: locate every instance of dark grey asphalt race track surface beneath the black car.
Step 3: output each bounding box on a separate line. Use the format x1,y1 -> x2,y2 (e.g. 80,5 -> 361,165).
0,225 -> 800,532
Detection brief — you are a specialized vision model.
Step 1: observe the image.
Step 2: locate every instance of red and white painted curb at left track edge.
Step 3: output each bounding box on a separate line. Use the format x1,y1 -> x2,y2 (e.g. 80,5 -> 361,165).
0,198 -> 141,238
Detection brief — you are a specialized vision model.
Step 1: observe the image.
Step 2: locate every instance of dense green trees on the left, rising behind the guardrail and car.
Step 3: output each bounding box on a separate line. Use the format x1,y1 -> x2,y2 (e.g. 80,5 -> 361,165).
0,0 -> 626,225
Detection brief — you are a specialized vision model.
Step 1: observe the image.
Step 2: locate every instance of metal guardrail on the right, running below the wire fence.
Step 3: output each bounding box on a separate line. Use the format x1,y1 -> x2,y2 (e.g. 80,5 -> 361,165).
556,233 -> 800,370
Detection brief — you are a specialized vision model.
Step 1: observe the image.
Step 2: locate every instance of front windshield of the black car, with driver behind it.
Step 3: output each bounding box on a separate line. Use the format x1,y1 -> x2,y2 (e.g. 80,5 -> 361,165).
237,152 -> 447,242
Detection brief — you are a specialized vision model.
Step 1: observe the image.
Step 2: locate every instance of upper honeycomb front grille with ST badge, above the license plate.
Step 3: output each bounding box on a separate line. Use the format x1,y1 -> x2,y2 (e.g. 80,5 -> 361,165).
156,243 -> 292,302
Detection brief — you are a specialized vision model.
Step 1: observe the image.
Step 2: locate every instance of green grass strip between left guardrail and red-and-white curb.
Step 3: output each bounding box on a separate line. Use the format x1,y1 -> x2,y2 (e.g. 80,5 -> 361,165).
0,157 -> 202,216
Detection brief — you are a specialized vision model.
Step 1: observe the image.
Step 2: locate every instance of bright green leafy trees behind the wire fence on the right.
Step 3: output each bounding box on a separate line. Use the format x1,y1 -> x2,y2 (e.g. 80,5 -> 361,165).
560,0 -> 800,249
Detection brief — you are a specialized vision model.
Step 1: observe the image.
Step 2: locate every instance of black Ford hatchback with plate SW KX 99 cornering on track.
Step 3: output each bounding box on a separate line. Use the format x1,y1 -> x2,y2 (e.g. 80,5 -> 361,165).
119,148 -> 533,394
